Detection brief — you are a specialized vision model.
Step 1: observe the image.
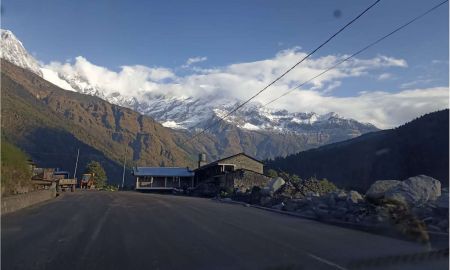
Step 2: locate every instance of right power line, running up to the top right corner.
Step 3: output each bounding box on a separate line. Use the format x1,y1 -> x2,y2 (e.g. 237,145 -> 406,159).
262,0 -> 448,107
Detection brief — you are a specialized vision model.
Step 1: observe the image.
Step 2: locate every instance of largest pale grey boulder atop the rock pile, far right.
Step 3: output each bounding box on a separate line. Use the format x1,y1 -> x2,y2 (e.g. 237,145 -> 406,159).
384,175 -> 441,205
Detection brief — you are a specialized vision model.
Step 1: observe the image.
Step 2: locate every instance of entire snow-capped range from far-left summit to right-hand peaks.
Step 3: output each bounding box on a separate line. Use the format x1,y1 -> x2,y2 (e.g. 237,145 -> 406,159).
1,30 -> 377,138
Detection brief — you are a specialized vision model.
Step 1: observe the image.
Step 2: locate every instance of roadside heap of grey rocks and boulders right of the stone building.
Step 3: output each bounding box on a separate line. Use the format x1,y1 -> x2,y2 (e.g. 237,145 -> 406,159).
234,175 -> 449,241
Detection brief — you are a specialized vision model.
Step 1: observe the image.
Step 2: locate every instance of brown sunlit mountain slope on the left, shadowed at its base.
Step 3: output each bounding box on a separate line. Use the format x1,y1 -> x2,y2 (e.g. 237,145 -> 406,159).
1,59 -> 195,185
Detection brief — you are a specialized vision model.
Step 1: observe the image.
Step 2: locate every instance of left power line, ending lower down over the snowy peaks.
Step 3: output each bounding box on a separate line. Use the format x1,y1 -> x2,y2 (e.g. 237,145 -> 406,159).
184,0 -> 381,143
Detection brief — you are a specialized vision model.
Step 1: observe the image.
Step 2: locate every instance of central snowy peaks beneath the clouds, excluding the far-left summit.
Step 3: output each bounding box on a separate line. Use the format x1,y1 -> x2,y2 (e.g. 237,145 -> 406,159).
132,96 -> 376,135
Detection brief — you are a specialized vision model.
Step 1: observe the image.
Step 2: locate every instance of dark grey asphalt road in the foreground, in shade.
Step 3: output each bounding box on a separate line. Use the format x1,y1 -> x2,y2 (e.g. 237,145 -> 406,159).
1,191 -> 448,270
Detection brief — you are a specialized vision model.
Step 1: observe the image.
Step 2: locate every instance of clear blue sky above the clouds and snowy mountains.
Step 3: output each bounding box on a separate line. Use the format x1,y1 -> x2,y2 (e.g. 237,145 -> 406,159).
2,0 -> 449,127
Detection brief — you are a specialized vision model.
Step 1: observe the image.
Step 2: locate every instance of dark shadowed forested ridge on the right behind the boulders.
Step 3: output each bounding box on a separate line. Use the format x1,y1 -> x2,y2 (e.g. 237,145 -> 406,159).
267,109 -> 449,192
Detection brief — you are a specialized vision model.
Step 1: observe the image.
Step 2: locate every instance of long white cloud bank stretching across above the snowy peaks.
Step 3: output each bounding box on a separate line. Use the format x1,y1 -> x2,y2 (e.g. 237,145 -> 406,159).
42,47 -> 448,128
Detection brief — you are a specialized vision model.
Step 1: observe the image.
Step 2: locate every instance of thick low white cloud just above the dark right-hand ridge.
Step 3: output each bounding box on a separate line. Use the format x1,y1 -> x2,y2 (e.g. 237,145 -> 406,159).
266,87 -> 449,128
